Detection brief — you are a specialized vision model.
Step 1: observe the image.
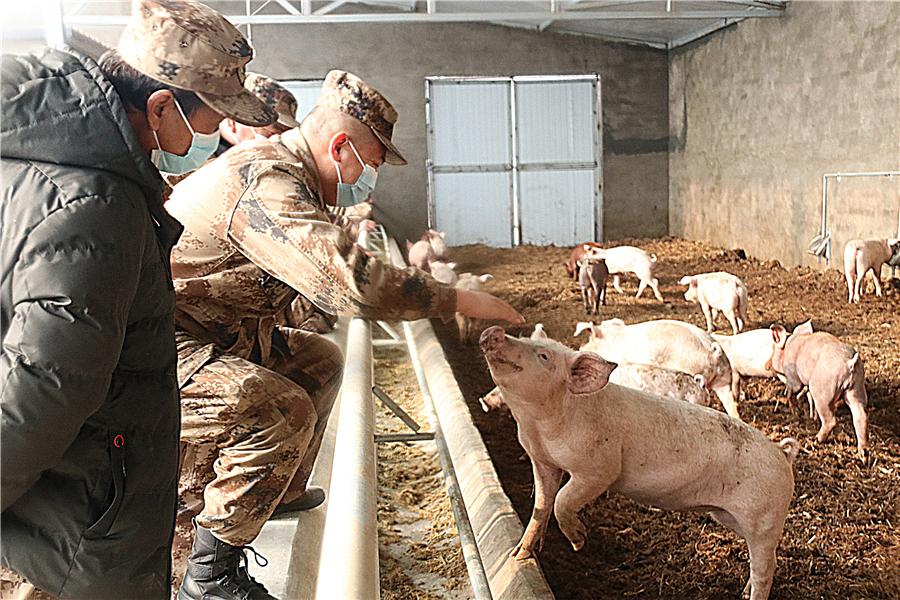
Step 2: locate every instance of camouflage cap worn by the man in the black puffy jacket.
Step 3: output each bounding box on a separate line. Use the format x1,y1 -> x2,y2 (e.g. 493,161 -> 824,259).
118,0 -> 276,127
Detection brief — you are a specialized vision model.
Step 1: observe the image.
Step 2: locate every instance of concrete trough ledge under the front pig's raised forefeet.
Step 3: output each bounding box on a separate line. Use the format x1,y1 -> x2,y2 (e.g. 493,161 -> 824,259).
409,319 -> 553,600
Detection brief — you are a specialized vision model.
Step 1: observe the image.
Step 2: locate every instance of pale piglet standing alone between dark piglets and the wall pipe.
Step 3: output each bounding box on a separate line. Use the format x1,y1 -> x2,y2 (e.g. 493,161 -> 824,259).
679,271 -> 749,334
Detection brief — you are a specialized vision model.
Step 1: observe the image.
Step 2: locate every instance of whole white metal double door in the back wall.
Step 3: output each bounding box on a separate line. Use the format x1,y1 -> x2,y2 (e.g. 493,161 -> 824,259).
426,75 -> 603,247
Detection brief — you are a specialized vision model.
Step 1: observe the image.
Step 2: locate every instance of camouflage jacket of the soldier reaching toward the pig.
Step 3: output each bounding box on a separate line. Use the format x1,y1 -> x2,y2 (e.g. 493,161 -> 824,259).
166,129 -> 456,359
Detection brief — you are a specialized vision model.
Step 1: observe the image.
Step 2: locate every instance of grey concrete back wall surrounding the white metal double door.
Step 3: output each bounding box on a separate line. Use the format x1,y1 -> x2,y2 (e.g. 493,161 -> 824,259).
246,24 -> 668,244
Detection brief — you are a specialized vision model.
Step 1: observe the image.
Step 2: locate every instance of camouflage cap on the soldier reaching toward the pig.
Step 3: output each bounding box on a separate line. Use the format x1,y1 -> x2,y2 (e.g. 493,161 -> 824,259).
316,71 -> 406,165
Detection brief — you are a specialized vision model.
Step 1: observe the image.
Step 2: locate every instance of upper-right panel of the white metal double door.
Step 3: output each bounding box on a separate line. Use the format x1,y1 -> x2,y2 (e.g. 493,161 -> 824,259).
516,81 -> 597,165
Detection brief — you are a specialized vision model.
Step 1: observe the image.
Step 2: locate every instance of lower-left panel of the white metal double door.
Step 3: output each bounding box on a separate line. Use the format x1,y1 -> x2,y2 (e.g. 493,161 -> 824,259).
434,173 -> 512,248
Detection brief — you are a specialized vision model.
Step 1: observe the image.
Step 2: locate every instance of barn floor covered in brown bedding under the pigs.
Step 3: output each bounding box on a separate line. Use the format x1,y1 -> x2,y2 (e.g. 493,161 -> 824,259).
436,238 -> 900,599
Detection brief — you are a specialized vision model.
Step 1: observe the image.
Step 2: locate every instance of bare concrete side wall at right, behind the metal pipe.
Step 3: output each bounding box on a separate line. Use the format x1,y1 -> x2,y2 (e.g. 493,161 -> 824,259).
669,2 -> 900,265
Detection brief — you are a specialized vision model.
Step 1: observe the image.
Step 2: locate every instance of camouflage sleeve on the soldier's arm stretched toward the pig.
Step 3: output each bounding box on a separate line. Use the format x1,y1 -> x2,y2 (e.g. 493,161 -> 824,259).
228,163 -> 456,320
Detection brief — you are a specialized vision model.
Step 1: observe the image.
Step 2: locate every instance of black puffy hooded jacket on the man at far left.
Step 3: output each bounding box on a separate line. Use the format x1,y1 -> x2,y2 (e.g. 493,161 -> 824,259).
0,50 -> 181,598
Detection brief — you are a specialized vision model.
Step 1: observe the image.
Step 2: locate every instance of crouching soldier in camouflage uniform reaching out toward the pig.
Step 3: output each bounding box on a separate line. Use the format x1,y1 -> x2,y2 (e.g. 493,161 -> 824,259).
167,71 -> 521,598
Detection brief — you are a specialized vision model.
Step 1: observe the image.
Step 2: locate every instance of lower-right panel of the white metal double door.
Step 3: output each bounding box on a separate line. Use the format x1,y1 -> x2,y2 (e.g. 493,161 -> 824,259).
519,169 -> 595,246
